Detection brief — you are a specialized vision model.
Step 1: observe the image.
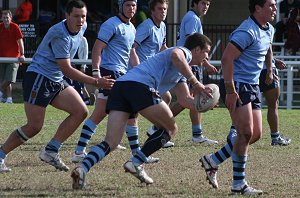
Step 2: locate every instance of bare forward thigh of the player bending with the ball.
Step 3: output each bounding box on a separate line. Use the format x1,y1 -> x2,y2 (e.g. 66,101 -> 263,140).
139,102 -> 177,133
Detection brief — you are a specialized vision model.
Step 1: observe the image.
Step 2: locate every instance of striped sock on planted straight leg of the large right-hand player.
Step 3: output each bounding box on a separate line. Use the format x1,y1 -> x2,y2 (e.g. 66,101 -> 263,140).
231,153 -> 247,186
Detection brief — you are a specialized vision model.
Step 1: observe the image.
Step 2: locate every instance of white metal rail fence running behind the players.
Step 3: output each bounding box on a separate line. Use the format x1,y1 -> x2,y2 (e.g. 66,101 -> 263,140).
0,56 -> 300,109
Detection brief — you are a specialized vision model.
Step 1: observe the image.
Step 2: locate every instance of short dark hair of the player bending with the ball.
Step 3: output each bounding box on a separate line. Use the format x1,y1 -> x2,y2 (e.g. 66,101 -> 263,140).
184,32 -> 211,50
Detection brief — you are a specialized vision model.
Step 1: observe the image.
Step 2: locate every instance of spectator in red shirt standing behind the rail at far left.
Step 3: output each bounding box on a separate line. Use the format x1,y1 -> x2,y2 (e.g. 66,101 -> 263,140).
0,10 -> 25,104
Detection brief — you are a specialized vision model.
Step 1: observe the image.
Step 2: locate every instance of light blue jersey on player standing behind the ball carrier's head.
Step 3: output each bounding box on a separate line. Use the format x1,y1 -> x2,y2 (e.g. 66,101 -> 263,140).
177,10 -> 203,46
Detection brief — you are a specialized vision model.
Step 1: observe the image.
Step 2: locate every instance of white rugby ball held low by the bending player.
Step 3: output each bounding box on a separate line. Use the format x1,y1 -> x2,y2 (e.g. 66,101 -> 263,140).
194,84 -> 220,112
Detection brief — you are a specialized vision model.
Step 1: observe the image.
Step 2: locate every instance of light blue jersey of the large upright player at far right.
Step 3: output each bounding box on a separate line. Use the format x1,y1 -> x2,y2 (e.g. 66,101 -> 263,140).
230,16 -> 274,85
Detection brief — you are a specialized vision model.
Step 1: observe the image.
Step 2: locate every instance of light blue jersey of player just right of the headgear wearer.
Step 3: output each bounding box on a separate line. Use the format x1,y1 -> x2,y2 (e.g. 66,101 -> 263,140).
135,18 -> 166,62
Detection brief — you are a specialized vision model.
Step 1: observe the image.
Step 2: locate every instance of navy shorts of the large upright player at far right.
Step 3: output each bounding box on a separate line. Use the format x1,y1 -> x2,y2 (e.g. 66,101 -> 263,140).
219,79 -> 261,109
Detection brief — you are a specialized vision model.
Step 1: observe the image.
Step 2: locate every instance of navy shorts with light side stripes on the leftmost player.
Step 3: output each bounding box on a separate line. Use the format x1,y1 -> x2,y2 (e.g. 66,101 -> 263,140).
22,72 -> 69,107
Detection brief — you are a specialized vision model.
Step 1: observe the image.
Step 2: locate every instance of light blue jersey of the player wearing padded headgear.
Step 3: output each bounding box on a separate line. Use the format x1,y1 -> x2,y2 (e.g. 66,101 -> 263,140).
97,16 -> 135,73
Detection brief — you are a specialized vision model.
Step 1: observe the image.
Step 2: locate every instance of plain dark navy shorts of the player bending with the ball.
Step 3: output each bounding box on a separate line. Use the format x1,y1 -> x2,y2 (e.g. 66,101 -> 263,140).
106,81 -> 162,118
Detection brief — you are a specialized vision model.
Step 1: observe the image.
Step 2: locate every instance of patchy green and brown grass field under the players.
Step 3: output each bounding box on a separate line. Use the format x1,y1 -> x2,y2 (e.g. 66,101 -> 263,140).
0,103 -> 300,198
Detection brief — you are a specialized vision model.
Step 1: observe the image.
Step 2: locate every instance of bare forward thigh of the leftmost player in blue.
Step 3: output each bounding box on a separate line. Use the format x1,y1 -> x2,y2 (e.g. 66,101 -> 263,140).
51,86 -> 88,116
